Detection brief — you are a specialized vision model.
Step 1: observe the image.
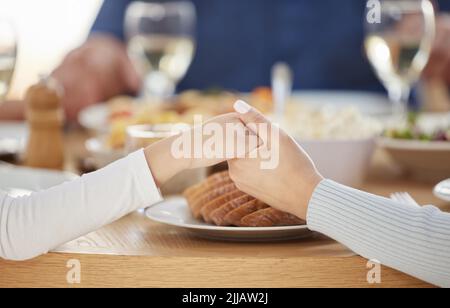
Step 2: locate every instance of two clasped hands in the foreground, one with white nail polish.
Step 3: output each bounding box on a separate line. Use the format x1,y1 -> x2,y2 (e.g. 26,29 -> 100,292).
145,102 -> 323,220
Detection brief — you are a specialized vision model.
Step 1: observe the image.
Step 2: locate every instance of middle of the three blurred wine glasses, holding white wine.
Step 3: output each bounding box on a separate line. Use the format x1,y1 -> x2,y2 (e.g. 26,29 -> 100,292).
125,1 -> 196,99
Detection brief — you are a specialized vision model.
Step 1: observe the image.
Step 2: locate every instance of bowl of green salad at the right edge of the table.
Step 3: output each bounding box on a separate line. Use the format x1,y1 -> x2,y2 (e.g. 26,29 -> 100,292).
378,113 -> 450,182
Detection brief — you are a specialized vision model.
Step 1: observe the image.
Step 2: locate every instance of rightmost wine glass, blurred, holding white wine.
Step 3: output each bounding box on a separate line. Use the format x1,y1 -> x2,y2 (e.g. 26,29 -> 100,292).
365,0 -> 436,117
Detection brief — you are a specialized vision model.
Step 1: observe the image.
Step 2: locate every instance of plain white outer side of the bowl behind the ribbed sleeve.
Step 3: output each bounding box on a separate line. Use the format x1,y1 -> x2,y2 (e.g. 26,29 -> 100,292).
298,138 -> 376,187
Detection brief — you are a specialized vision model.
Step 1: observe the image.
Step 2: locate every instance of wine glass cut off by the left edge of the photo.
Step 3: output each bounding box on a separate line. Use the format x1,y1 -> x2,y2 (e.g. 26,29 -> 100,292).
0,19 -> 17,104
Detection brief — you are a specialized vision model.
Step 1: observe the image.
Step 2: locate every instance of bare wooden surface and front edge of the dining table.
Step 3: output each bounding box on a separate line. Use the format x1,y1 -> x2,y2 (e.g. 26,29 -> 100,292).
0,130 -> 450,288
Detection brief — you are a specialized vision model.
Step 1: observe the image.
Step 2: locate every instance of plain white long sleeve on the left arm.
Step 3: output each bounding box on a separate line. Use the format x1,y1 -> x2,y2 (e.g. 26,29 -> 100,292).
0,151 -> 162,260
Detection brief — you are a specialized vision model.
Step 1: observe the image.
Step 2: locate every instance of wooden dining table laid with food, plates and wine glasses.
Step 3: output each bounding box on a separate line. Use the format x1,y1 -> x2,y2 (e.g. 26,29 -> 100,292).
0,0 -> 450,289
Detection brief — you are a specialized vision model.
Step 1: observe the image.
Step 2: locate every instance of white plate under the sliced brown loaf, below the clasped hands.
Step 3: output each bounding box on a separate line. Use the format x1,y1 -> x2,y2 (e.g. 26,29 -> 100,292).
145,197 -> 313,241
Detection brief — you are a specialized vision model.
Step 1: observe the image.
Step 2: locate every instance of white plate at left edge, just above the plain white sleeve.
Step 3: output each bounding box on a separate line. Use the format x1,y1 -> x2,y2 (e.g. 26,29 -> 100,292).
0,164 -> 77,196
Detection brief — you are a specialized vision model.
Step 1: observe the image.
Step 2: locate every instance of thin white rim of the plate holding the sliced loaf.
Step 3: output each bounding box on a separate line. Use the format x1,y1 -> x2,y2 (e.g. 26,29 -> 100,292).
145,197 -> 308,232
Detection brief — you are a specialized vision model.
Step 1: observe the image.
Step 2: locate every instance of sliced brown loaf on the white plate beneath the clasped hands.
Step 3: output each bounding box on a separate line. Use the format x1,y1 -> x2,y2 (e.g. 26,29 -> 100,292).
184,171 -> 305,227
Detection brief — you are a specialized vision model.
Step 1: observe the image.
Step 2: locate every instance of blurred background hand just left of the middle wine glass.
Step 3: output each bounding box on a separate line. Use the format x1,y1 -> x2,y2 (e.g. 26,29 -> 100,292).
52,35 -> 141,120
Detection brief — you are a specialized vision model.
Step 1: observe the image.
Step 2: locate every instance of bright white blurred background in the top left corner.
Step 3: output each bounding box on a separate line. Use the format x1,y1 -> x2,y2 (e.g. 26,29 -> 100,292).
0,0 -> 103,99
